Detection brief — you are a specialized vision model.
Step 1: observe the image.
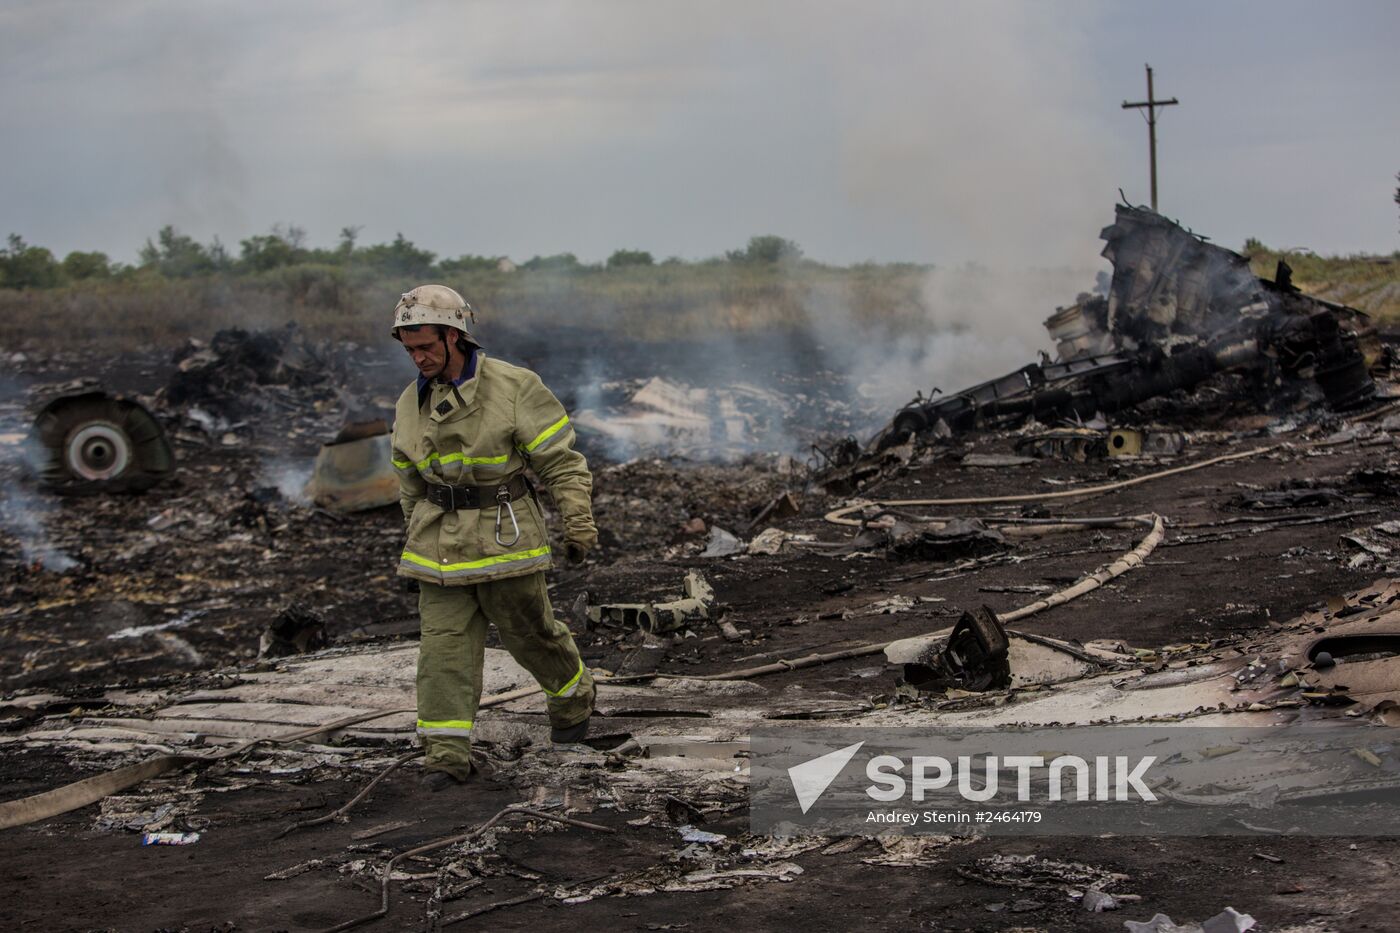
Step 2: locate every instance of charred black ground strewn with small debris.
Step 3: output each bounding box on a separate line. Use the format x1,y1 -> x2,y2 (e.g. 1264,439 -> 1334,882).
0,343 -> 1400,930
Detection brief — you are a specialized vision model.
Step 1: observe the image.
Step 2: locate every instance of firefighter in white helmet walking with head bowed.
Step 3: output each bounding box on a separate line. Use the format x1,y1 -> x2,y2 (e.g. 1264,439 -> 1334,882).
392,284 -> 598,790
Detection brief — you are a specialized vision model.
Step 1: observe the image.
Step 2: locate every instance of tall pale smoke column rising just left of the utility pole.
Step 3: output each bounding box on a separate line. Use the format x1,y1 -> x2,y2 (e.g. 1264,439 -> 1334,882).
784,3 -> 1116,427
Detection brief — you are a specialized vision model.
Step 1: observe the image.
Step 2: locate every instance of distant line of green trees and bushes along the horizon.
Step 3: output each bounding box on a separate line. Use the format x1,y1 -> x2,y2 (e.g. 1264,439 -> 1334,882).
0,224 -> 816,289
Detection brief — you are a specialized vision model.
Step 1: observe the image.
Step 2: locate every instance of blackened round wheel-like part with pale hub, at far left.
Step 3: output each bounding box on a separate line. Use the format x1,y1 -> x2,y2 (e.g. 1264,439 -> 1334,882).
29,389 -> 175,495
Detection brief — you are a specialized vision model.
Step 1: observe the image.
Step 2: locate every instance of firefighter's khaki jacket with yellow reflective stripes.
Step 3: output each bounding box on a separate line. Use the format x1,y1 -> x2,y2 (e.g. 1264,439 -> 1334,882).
393,349 -> 598,586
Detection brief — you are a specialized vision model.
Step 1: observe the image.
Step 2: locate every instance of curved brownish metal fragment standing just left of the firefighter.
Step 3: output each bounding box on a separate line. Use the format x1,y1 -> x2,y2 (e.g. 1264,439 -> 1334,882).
305,417 -> 399,513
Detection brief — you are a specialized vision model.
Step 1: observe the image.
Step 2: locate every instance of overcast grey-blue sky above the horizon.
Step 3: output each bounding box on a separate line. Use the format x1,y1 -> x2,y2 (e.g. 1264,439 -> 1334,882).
0,0 -> 1400,265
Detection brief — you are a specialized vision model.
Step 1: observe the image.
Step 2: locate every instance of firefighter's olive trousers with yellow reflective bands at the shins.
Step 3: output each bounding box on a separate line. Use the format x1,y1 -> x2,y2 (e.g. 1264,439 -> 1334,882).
417,572 -> 594,780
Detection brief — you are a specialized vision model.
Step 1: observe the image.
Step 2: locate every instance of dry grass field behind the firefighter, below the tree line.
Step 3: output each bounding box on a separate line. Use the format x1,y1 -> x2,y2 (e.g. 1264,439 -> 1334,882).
0,262 -> 927,350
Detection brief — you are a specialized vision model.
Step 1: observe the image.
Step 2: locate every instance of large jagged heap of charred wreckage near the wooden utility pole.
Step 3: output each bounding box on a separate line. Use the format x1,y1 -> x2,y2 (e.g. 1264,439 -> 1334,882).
875,205 -> 1379,450
